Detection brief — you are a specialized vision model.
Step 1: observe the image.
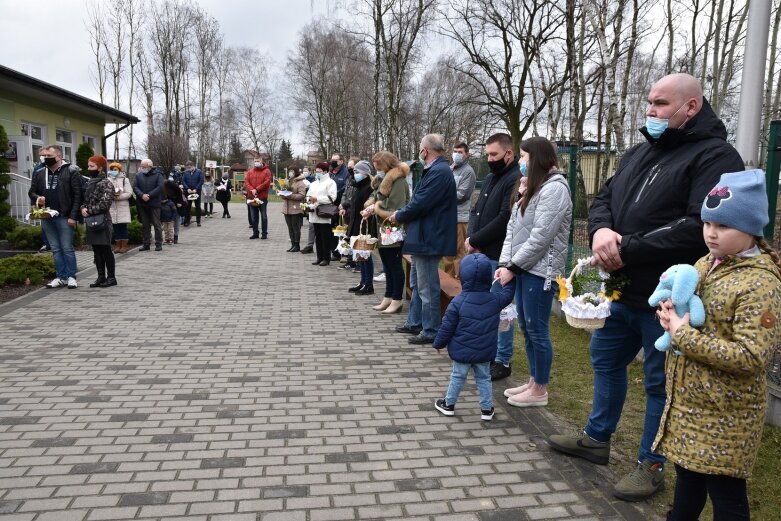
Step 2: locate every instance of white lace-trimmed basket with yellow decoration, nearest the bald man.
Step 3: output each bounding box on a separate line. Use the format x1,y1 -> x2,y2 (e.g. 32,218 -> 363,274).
556,257 -> 628,331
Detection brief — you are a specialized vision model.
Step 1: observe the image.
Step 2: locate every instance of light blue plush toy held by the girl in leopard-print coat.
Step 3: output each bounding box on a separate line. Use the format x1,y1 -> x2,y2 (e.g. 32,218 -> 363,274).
648,264 -> 705,354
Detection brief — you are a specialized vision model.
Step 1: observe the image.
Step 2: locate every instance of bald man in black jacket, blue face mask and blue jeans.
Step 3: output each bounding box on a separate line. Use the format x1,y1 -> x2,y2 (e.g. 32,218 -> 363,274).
548,74 -> 744,501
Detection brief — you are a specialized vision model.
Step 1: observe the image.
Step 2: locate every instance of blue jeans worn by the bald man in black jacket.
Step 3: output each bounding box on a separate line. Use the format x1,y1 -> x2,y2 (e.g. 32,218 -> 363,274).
585,302 -> 665,463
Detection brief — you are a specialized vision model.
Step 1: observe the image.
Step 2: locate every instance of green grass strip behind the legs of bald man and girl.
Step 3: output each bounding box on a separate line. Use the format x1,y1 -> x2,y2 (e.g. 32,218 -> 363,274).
513,317 -> 781,521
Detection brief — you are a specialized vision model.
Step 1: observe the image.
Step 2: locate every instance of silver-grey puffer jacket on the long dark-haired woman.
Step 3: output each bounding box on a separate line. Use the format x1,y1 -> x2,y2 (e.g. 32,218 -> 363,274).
499,172 -> 572,289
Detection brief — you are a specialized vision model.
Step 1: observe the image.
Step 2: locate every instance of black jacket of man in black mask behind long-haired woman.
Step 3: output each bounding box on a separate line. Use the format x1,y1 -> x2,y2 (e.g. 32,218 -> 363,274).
467,159 -> 521,261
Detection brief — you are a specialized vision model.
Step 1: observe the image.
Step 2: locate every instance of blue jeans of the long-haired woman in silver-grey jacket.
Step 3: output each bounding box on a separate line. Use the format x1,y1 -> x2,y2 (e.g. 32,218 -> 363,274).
515,271 -> 559,385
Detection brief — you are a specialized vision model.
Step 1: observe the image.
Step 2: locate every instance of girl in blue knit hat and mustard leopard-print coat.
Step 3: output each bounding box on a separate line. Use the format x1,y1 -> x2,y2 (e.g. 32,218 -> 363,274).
654,170 -> 781,521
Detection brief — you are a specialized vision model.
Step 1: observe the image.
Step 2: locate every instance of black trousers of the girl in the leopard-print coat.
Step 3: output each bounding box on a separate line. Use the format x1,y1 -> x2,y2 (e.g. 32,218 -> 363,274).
667,465 -> 749,521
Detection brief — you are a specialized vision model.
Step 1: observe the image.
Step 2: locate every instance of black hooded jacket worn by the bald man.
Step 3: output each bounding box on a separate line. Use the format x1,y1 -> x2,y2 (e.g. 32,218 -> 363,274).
588,100 -> 745,308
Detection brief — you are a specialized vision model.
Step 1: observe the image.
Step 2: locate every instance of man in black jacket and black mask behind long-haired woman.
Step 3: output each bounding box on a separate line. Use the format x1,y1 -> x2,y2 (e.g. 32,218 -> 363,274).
464,133 -> 520,380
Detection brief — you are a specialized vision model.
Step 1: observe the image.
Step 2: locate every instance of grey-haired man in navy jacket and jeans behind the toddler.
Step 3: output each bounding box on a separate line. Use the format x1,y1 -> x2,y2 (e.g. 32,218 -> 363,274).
390,134 -> 458,344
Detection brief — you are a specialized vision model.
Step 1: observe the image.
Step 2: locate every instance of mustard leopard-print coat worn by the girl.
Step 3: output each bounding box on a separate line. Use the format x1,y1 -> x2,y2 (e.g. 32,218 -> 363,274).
654,254 -> 781,479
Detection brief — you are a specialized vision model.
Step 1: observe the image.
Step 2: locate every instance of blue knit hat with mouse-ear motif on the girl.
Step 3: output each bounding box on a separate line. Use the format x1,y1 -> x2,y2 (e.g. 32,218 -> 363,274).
701,170 -> 769,237
